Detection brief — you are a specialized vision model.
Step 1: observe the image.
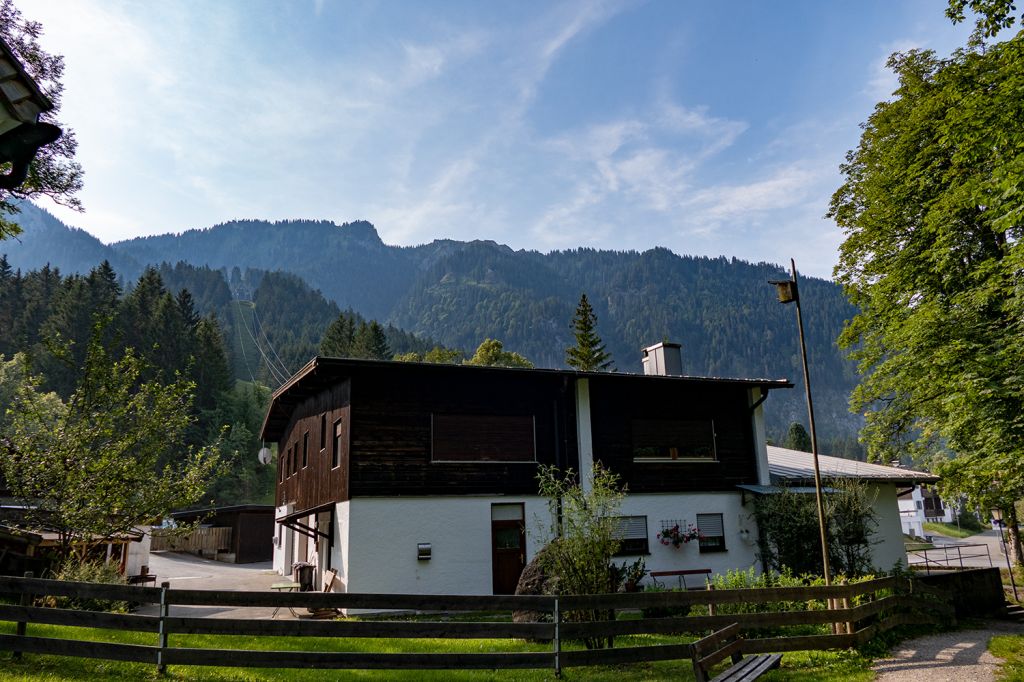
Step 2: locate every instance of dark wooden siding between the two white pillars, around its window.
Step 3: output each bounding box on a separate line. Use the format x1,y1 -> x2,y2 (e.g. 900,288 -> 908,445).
590,377 -> 758,493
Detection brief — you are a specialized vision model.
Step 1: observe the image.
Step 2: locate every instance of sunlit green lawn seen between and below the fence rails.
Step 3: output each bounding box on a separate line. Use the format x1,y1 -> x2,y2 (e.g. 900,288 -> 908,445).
0,623 -> 872,682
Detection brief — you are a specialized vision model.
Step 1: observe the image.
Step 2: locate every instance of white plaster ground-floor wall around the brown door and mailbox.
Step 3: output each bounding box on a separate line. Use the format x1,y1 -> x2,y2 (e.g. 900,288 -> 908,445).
338,496 -> 550,594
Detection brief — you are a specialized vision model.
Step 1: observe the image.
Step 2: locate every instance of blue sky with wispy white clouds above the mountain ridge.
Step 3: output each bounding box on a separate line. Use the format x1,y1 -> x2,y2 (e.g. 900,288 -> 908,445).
15,0 -> 970,278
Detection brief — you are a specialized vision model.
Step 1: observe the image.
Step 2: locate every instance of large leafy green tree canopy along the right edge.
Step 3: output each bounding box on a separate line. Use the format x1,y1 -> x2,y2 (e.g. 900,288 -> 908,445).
829,23 -> 1024,544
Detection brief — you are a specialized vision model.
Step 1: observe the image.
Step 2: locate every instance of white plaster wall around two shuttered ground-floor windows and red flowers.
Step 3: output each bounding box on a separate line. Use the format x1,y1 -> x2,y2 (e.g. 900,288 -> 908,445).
615,492 -> 761,587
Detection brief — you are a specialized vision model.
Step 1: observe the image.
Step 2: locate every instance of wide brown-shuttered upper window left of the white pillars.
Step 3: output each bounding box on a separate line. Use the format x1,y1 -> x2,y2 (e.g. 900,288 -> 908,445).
432,415 -> 537,462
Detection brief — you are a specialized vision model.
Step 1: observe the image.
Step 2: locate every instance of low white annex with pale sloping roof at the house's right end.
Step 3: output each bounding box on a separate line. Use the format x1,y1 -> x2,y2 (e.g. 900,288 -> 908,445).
768,445 -> 939,570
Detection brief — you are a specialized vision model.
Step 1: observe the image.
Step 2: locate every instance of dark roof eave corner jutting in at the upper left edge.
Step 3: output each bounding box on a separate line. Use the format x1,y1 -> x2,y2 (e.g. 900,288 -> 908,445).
0,34 -> 61,189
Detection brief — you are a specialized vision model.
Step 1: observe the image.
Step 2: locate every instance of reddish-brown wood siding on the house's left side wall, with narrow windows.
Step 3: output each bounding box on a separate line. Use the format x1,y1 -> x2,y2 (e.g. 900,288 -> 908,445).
276,378 -> 351,511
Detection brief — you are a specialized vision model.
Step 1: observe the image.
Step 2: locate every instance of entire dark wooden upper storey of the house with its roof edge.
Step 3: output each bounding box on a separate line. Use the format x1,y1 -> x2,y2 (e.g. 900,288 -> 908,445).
263,358 -> 790,511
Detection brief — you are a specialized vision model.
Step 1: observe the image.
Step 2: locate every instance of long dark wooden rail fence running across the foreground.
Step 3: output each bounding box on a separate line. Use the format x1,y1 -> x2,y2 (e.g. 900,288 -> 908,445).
0,577 -> 955,674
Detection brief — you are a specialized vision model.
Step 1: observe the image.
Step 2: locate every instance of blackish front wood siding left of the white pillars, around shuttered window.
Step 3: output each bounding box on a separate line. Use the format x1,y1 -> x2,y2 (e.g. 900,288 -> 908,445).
350,365 -> 578,497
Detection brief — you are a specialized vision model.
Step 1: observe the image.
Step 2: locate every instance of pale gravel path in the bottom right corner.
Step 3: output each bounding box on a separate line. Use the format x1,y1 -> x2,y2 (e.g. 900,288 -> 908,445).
871,621 -> 1024,682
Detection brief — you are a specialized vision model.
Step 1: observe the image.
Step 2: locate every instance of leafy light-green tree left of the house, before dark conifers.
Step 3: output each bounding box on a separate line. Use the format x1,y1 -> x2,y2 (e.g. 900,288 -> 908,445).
0,325 -> 219,559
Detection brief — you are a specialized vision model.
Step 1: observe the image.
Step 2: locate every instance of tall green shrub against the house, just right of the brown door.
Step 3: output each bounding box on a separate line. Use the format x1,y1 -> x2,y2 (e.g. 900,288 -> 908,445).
537,462 -> 624,648
